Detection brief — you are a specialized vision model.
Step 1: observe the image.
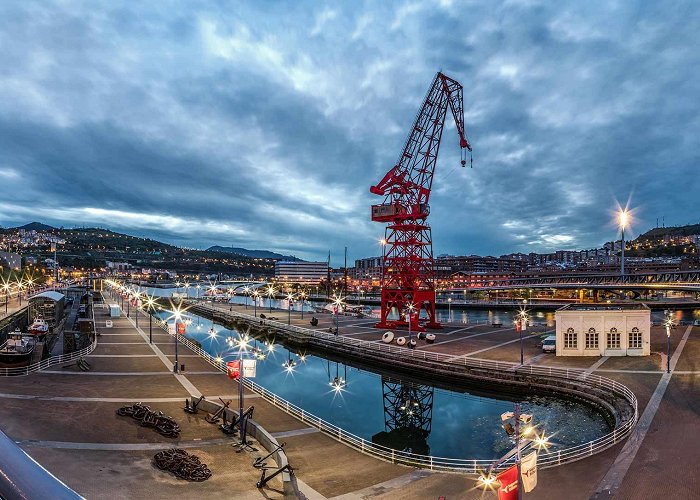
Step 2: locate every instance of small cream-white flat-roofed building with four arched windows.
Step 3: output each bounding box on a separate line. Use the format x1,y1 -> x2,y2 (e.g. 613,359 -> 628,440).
554,304 -> 651,356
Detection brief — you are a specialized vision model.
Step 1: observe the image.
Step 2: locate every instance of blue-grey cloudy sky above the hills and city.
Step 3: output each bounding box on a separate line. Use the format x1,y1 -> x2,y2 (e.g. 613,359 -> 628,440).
0,0 -> 700,260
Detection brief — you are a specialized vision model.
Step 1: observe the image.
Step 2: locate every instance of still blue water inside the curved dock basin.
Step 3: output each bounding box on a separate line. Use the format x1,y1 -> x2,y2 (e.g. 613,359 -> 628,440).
149,313 -> 609,459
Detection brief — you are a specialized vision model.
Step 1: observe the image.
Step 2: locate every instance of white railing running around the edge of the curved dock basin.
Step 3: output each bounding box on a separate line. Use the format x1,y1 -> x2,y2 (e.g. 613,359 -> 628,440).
157,309 -> 638,474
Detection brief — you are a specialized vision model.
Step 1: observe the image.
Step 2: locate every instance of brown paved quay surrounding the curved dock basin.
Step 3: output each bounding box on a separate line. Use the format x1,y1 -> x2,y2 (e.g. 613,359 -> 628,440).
0,292 -> 700,500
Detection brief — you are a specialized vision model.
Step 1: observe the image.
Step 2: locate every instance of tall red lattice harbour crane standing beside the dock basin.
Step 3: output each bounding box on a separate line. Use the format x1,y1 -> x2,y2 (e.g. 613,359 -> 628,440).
370,73 -> 472,330
